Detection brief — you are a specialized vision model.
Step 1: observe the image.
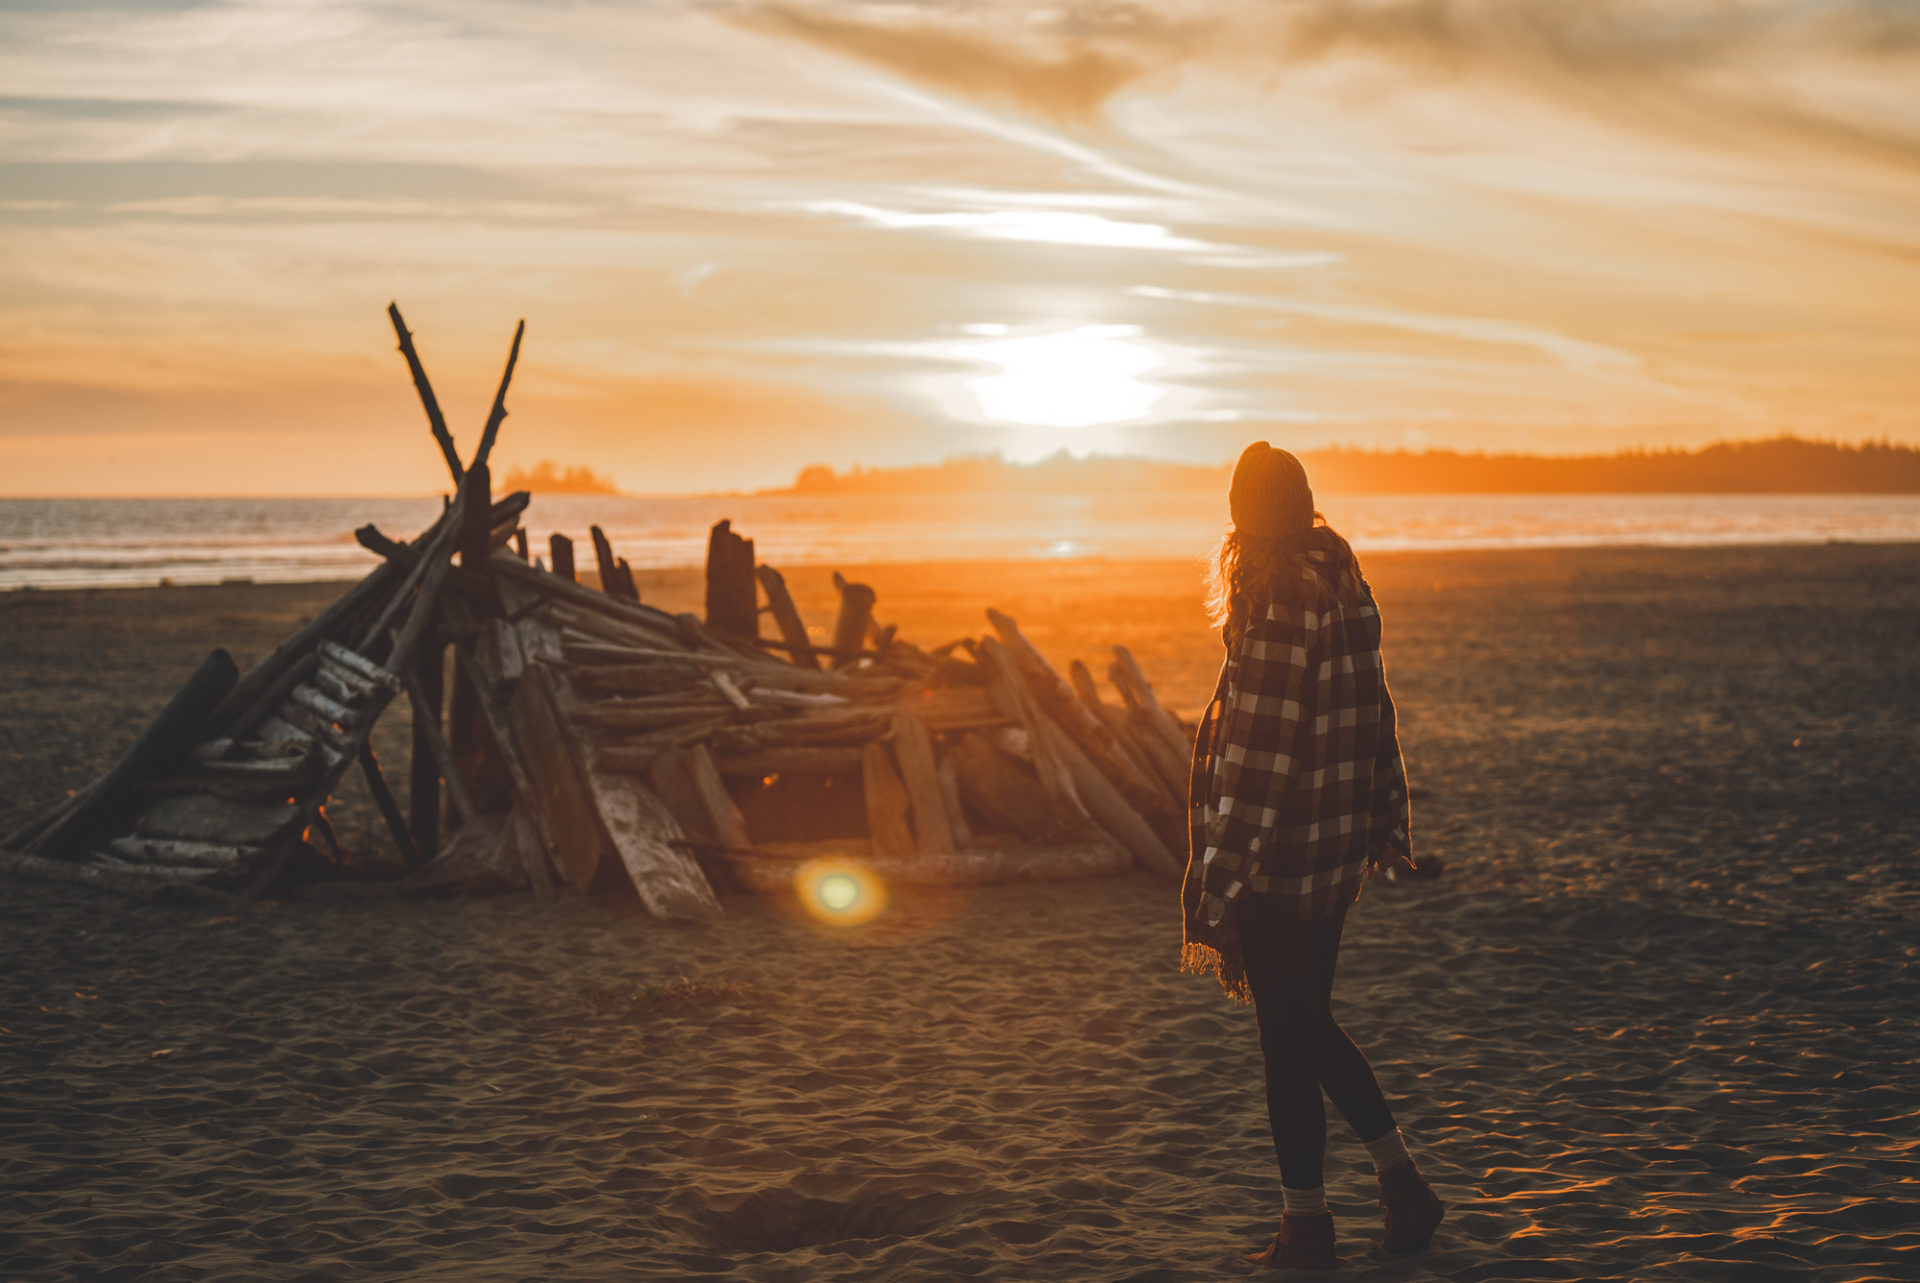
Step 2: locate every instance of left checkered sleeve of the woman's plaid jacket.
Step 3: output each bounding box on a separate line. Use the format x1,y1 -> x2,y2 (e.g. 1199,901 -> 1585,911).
1200,605 -> 1323,926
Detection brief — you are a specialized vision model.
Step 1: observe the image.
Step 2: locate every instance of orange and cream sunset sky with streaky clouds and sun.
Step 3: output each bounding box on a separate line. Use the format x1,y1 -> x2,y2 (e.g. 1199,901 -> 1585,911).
0,0 -> 1920,496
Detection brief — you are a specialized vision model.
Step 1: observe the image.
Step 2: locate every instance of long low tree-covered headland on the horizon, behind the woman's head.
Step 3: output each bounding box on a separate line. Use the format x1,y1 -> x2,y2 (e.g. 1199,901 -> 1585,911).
760,436 -> 1920,496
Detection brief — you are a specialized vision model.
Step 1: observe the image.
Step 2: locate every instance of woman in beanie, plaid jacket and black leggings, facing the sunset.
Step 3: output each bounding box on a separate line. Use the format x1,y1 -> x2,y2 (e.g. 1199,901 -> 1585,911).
1181,442 -> 1442,1270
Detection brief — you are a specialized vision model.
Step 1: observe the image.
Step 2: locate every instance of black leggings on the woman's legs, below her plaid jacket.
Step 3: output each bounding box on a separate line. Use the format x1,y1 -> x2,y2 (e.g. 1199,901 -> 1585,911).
1235,895 -> 1394,1189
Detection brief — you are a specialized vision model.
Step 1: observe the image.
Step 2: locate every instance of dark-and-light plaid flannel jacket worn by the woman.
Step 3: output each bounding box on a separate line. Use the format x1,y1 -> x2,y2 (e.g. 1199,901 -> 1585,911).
1196,553 -> 1413,928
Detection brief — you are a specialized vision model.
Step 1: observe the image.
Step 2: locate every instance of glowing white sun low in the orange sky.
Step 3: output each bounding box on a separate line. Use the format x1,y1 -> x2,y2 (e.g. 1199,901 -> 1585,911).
966,325 -> 1167,428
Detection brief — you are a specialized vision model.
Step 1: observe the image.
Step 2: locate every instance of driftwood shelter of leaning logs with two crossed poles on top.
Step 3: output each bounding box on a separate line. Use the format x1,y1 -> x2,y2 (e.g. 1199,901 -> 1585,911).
0,307 -> 1192,918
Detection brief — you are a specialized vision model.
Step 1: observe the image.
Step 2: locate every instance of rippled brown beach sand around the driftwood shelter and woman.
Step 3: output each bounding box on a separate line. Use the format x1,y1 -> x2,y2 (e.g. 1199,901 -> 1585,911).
0,545 -> 1920,1281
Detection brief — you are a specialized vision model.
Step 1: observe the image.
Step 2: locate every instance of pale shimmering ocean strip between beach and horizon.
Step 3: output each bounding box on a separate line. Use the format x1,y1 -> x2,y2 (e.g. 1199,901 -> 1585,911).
0,494 -> 1920,590
